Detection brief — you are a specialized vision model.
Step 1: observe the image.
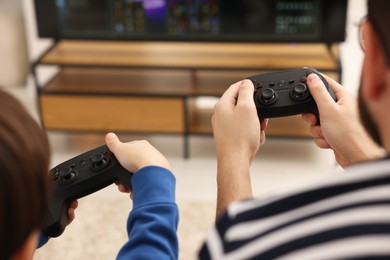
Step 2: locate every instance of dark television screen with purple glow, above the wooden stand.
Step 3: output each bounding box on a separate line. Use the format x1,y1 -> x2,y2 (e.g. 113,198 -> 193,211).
35,0 -> 347,42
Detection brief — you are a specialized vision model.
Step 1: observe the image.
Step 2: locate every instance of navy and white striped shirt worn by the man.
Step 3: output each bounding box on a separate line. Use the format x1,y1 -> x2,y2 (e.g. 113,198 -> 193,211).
199,157 -> 390,260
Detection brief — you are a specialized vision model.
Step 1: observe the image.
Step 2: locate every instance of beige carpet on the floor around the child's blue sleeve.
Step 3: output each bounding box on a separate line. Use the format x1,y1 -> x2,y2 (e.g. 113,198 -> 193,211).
33,194 -> 215,260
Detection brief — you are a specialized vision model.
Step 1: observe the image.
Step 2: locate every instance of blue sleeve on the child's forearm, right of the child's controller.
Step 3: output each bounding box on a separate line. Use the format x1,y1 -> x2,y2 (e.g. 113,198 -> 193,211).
117,166 -> 179,259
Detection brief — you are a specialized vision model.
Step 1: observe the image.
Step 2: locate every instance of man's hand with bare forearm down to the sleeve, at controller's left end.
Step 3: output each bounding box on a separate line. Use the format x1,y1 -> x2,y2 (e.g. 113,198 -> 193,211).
212,80 -> 267,217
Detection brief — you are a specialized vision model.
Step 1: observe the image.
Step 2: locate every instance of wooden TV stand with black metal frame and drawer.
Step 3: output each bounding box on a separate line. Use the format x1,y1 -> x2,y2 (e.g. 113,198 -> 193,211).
33,40 -> 341,157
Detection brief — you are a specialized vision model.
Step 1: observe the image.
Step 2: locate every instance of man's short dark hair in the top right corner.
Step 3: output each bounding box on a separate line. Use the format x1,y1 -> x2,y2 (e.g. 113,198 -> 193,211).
367,0 -> 390,67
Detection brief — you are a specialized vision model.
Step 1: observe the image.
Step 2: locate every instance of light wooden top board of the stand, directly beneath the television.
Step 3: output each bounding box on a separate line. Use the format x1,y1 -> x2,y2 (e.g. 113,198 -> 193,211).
38,40 -> 339,71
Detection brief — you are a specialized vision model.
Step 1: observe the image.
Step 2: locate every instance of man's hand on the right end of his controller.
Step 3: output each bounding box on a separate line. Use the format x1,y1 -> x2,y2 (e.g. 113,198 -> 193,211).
302,73 -> 383,167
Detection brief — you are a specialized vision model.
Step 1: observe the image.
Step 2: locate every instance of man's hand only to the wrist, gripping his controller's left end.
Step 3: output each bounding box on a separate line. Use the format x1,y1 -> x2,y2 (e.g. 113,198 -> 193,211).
212,80 -> 266,164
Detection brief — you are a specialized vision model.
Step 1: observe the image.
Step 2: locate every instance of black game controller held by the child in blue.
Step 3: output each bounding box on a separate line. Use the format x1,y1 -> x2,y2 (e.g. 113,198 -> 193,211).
43,145 -> 133,237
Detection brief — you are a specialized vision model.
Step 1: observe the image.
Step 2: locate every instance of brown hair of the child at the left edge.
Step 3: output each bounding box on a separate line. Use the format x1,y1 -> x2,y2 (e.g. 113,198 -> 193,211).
0,89 -> 50,259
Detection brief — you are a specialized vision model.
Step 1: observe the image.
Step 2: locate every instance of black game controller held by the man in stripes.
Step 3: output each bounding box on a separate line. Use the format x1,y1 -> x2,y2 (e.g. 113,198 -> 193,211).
248,68 -> 336,120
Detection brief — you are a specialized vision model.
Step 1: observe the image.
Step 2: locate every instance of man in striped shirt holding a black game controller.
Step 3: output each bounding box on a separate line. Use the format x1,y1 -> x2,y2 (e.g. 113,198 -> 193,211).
199,0 -> 390,259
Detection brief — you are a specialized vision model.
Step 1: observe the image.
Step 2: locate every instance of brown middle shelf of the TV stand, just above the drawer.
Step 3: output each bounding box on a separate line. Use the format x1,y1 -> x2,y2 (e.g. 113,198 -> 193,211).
42,67 -> 247,97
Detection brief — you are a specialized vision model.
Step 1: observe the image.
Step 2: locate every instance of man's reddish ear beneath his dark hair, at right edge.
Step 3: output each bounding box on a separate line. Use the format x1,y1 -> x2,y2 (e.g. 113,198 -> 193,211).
362,21 -> 387,100
